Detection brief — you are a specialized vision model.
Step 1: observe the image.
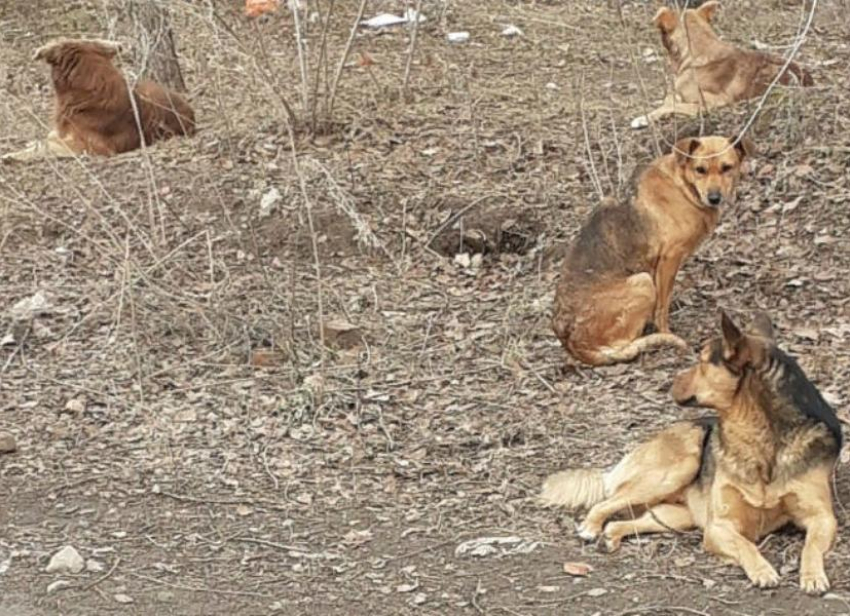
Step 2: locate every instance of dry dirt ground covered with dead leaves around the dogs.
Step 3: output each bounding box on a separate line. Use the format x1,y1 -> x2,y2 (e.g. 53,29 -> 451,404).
0,0 -> 850,616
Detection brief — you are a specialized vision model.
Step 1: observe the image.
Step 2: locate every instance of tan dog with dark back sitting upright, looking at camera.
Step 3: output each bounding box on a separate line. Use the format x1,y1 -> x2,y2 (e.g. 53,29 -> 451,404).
552,137 -> 752,366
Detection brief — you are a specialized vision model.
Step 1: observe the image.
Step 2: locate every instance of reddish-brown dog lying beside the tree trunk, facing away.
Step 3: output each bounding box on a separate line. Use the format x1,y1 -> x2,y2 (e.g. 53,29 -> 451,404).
3,40 -> 195,161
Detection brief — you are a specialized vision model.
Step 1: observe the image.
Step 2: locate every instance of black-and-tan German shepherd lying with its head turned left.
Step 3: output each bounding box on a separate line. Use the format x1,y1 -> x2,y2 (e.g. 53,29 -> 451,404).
541,314 -> 841,592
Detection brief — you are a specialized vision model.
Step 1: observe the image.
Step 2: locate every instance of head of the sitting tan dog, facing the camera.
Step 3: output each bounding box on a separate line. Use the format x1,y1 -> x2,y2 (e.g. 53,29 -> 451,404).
673,136 -> 755,209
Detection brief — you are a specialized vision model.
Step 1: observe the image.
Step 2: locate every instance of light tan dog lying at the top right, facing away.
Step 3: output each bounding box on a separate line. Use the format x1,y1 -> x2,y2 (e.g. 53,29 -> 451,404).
632,2 -> 814,128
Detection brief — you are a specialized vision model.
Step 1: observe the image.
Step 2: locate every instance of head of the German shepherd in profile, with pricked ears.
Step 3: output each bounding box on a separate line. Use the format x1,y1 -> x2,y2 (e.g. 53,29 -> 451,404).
671,312 -> 775,411
